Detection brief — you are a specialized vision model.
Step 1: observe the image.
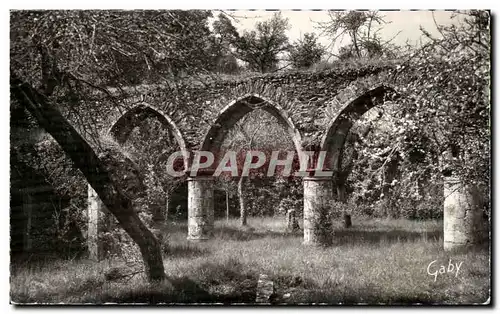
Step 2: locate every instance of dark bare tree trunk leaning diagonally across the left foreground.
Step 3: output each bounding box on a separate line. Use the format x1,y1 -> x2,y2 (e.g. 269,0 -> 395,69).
10,76 -> 166,281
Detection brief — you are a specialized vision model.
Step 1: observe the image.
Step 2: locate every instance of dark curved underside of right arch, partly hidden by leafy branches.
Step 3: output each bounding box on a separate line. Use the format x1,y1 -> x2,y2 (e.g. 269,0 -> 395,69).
321,85 -> 394,175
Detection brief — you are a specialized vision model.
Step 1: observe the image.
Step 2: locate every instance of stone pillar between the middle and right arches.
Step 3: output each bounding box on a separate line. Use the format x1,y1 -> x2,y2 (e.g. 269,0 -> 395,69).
303,177 -> 333,245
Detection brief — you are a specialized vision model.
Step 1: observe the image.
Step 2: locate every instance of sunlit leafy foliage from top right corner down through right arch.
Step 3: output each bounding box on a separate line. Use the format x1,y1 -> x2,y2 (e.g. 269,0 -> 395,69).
334,11 -> 490,219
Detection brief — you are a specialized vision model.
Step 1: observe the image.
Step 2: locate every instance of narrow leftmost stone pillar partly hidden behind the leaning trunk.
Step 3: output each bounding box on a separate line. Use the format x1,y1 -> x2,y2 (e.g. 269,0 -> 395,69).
87,184 -> 104,261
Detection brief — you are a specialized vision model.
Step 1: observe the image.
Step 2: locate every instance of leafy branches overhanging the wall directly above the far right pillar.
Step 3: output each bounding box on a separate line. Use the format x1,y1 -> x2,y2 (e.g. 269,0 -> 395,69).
398,11 -> 491,184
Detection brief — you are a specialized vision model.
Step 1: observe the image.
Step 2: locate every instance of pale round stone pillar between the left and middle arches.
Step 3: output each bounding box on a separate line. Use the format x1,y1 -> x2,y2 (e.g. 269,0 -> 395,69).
187,175 -> 214,241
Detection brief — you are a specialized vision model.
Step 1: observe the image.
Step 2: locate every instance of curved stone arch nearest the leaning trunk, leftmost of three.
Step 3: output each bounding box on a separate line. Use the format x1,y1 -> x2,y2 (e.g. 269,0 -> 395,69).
109,103 -> 189,169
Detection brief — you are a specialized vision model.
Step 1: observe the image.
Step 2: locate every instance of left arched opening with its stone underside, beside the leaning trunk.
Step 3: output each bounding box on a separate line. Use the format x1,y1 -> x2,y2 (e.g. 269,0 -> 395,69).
102,104 -> 189,244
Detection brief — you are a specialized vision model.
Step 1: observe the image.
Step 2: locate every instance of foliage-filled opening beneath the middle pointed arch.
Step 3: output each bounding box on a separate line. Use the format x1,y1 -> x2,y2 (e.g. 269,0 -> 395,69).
214,109 -> 302,231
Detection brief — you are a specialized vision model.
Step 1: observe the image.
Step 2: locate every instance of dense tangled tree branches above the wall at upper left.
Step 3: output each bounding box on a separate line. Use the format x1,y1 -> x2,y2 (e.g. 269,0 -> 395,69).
11,10 -> 220,86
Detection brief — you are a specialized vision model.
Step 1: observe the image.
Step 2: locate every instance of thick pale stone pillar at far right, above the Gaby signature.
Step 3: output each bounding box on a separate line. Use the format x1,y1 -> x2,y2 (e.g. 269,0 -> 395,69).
443,176 -> 484,250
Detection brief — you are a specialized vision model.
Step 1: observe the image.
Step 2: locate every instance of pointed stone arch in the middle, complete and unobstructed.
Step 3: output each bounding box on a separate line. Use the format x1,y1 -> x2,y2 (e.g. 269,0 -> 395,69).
200,94 -> 302,166
